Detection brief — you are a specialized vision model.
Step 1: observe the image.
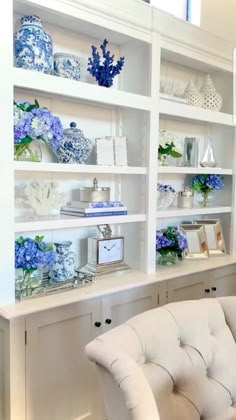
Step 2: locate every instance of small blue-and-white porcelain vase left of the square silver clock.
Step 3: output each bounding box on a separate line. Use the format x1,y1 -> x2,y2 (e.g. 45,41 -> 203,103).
52,241 -> 75,282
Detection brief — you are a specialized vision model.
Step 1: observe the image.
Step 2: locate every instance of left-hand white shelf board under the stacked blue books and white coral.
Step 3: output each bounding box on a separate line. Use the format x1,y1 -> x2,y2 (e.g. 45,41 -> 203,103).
15,214 -> 146,233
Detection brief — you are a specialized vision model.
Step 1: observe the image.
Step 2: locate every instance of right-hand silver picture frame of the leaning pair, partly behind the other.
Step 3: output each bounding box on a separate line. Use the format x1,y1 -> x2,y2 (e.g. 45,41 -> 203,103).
194,219 -> 226,257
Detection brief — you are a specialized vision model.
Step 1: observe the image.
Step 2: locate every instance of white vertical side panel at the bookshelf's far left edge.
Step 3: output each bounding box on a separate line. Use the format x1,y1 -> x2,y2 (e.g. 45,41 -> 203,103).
0,0 -> 15,305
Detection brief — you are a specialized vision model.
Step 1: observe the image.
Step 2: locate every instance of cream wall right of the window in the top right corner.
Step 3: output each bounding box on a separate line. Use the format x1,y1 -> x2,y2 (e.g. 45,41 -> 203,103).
201,0 -> 236,43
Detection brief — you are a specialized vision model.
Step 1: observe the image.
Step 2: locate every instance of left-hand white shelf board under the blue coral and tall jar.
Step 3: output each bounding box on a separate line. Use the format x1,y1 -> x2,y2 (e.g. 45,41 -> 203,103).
13,68 -> 151,111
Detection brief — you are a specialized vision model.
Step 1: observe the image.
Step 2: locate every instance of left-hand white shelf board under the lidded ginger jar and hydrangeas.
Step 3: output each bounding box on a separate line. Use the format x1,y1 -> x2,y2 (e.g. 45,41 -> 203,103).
14,162 -> 147,175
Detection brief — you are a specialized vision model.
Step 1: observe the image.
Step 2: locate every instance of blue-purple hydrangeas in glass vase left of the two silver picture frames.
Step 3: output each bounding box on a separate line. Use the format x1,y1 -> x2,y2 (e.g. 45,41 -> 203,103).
156,226 -> 188,265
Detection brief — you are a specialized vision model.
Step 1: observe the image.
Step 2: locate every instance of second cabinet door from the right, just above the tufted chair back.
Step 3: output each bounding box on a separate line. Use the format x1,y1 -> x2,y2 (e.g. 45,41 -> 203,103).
168,272 -> 210,302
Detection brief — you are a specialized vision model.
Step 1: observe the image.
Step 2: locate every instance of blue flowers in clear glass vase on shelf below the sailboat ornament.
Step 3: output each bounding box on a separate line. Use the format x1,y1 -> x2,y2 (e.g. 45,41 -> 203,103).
192,175 -> 224,207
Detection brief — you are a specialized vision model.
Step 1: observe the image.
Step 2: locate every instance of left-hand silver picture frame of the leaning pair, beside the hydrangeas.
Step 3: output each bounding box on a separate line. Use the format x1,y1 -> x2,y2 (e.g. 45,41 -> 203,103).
180,223 -> 209,260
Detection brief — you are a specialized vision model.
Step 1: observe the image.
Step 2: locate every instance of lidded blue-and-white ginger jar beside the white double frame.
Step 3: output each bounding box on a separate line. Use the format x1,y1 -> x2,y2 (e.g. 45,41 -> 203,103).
56,122 -> 93,163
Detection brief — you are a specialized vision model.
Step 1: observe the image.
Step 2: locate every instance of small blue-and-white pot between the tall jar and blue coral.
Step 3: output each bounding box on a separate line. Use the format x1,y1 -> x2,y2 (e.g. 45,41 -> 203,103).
54,53 -> 80,80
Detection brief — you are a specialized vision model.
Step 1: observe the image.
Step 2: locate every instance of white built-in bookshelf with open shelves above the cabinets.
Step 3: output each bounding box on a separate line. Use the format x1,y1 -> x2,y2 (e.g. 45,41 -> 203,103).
0,0 -> 236,304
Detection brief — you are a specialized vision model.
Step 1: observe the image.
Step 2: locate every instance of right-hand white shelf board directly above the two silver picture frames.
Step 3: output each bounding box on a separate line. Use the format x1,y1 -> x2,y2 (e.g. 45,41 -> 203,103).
157,206 -> 232,219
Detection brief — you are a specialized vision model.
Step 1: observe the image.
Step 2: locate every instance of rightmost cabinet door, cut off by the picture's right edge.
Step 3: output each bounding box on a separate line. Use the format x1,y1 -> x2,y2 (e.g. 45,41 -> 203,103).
210,265 -> 236,297
